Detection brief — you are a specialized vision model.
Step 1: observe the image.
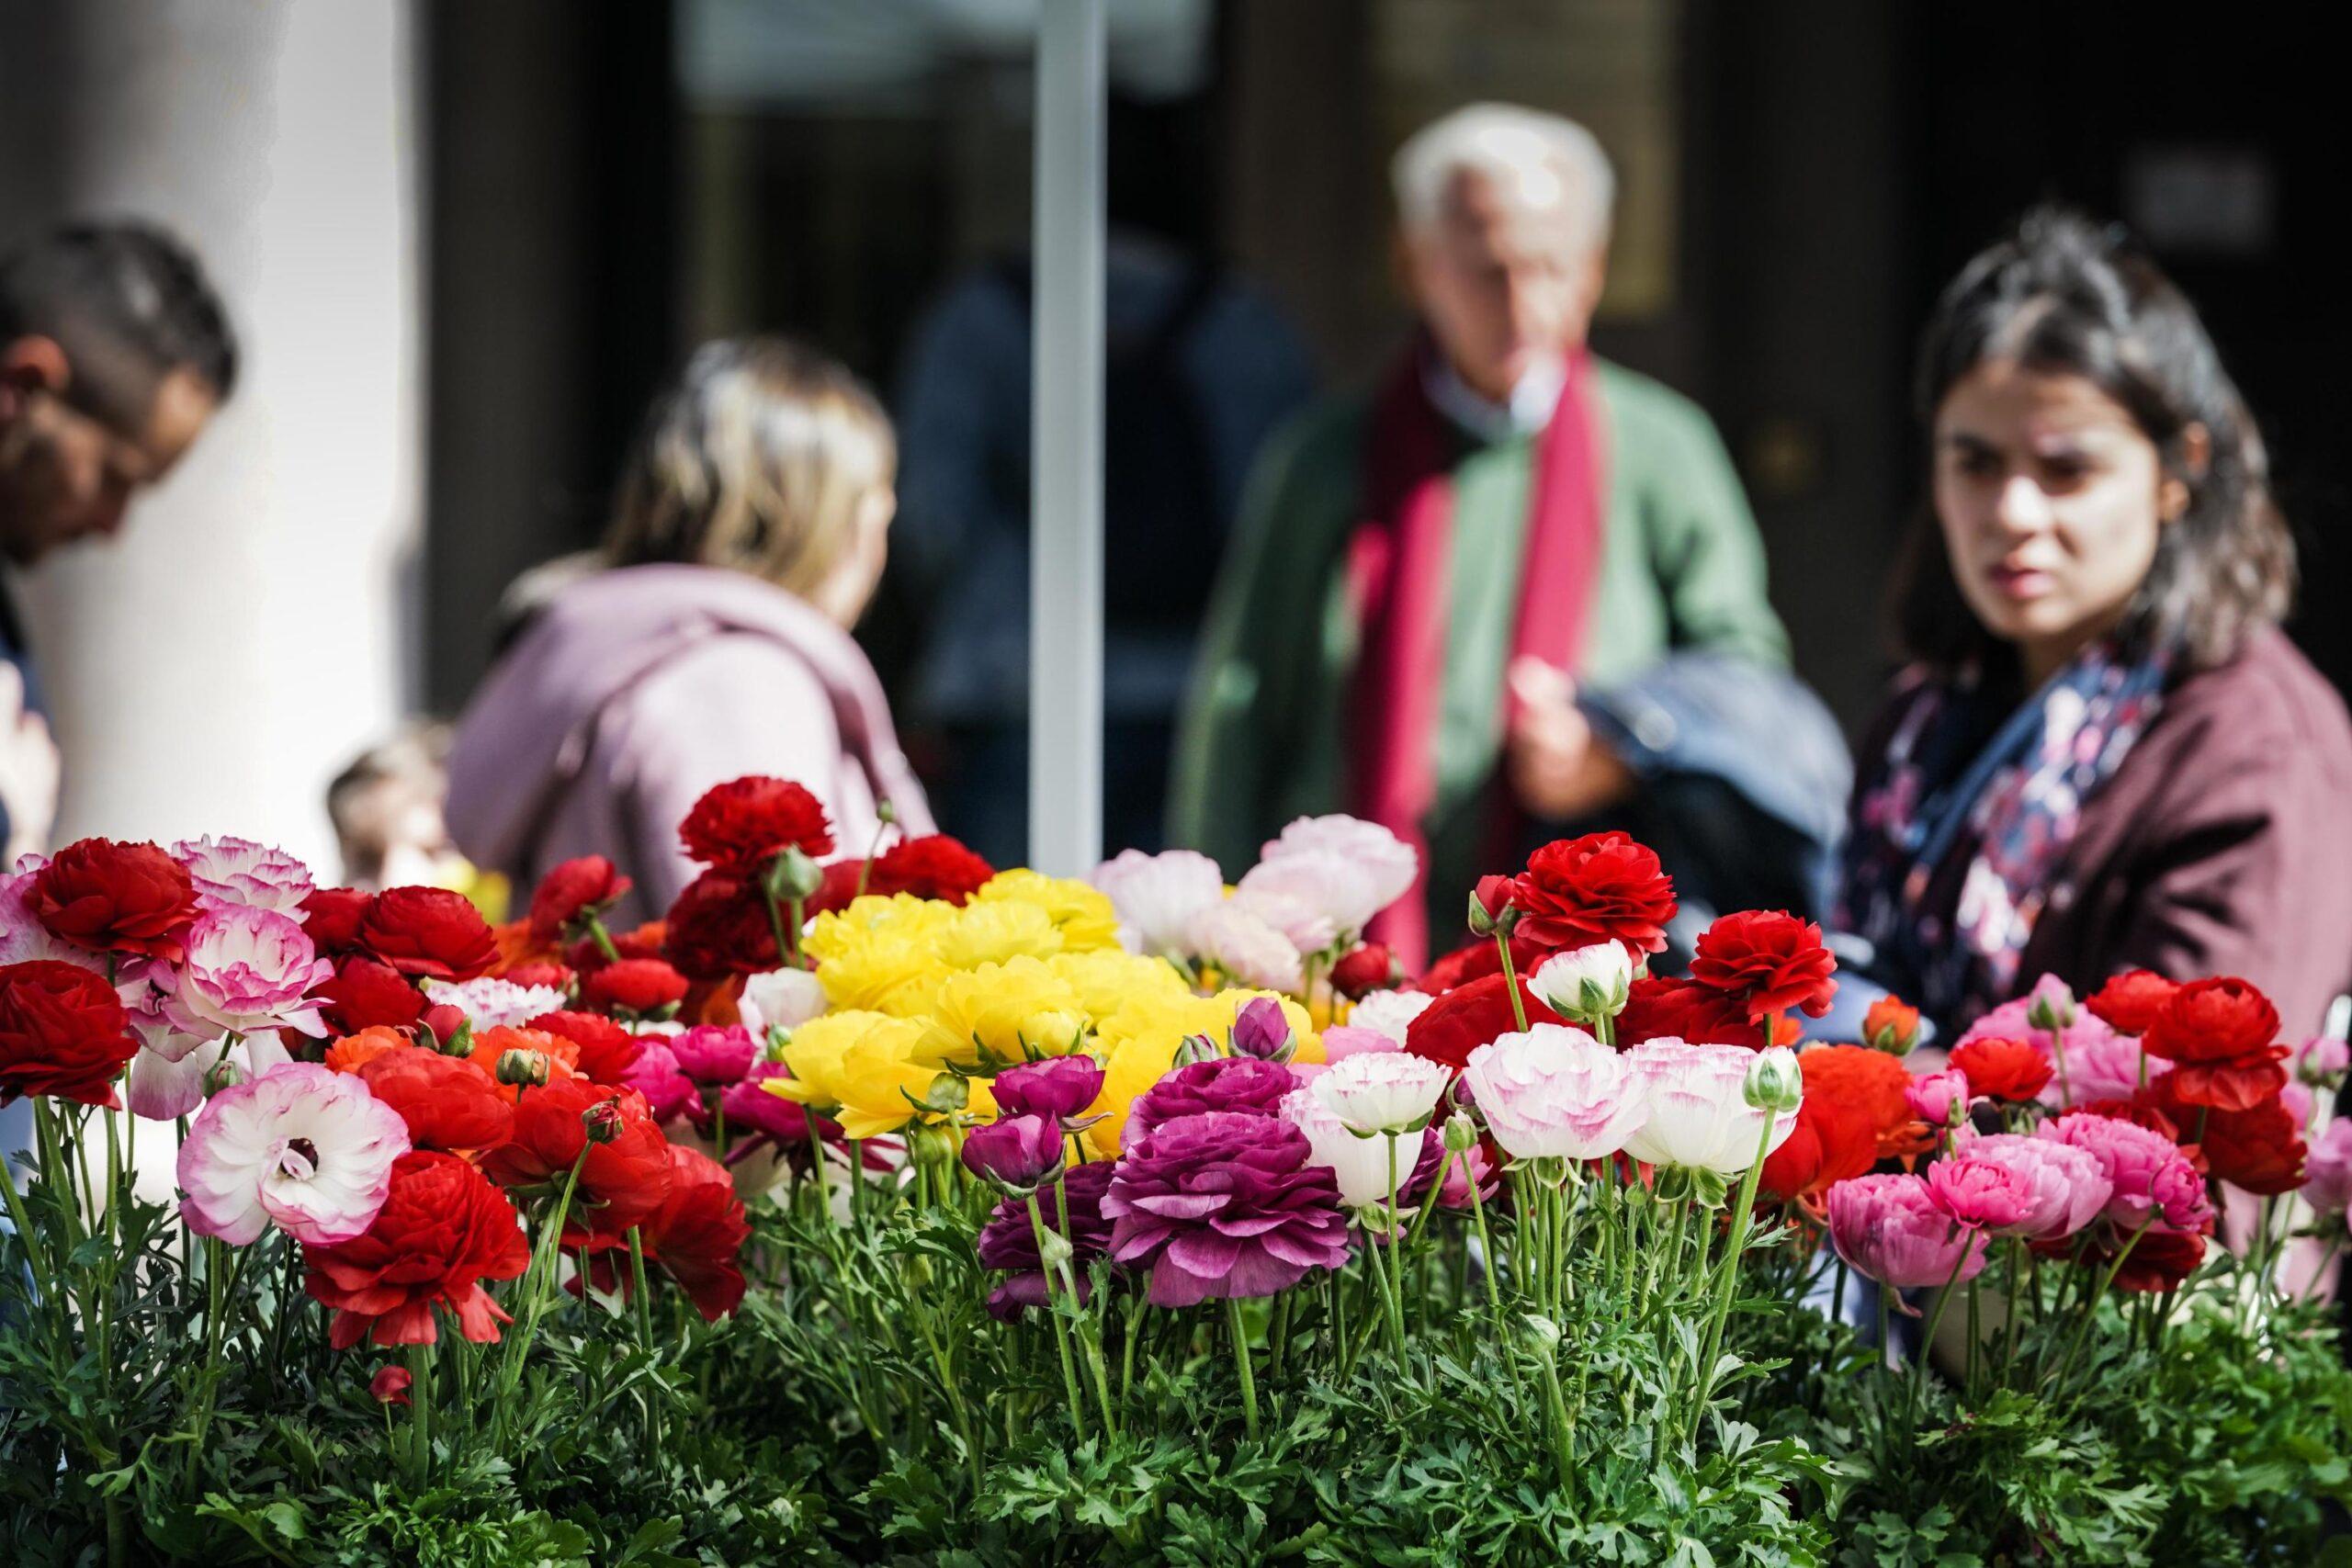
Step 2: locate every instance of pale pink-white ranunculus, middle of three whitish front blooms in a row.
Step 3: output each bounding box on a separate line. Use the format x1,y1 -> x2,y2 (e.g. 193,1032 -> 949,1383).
1463,1022 -> 1646,1159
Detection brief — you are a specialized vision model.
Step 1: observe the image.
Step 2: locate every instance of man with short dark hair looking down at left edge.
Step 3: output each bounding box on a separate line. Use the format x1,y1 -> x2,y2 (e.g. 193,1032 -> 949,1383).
0,221 -> 238,861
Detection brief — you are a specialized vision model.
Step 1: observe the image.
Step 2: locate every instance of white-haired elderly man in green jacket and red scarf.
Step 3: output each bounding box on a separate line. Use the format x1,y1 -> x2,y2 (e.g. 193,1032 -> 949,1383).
1171,104 -> 1844,964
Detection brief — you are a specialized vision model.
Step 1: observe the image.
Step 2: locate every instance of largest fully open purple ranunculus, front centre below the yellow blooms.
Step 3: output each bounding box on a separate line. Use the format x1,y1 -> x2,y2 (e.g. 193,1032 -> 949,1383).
1103,1109 -> 1348,1307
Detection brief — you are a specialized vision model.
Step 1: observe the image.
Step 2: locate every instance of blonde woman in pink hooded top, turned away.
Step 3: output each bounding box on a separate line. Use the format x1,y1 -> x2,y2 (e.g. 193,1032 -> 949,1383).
449,339 -> 932,921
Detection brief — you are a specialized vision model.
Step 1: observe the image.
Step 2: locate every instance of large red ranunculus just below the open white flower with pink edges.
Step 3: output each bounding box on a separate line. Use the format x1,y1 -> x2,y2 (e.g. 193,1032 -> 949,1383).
301,1149 -> 532,1349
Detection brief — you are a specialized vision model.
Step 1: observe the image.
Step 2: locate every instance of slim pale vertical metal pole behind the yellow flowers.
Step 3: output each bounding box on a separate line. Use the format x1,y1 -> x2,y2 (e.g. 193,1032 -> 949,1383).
1030,0 -> 1103,877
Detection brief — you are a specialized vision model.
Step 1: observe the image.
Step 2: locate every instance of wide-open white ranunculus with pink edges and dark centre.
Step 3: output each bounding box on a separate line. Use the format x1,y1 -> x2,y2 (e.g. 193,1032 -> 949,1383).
179,1063 -> 409,1246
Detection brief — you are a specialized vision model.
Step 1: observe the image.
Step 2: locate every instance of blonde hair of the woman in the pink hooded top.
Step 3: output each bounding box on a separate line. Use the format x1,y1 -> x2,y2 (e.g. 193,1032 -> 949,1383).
605,339 -> 899,594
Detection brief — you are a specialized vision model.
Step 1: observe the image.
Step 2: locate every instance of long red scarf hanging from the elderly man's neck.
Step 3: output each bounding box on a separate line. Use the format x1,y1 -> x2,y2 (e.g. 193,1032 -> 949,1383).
1348,350 -> 1606,971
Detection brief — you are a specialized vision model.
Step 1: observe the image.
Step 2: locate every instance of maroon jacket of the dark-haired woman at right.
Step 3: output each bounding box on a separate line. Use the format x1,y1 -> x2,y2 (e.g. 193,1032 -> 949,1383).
1865,630 -> 2352,1039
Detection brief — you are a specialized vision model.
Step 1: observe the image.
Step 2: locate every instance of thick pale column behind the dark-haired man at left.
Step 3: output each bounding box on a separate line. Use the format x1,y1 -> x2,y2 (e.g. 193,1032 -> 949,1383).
0,0 -> 419,877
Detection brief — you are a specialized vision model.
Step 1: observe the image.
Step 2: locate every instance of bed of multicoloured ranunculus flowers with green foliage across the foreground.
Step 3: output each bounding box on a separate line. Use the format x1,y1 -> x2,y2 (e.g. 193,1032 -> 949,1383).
0,799 -> 2352,1565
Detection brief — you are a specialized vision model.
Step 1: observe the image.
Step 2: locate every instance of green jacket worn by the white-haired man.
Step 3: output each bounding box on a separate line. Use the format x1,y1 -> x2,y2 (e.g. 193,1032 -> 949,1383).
1169,360 -> 1788,931
